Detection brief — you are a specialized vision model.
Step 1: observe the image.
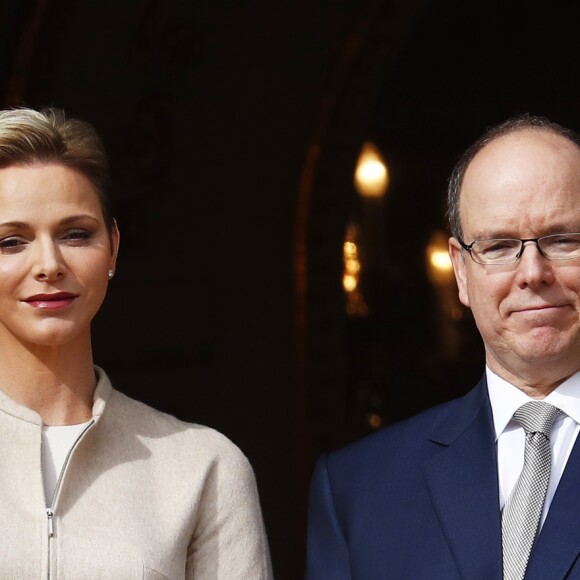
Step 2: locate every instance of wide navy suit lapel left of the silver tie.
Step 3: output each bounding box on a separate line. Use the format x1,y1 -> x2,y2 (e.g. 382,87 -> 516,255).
423,380 -> 502,580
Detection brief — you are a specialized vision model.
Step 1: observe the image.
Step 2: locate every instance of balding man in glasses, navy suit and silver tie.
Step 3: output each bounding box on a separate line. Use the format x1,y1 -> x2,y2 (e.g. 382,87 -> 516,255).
307,116 -> 580,580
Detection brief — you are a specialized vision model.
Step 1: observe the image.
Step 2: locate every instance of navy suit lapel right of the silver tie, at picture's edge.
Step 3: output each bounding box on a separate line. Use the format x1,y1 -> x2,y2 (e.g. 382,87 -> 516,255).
526,432 -> 580,580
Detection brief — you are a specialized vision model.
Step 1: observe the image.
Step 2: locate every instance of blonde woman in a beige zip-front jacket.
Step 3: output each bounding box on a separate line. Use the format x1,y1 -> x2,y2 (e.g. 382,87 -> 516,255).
0,109 -> 271,580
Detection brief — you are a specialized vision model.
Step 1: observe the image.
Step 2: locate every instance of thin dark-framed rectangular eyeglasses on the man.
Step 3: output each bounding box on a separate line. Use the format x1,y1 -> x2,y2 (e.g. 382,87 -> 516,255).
459,233 -> 580,266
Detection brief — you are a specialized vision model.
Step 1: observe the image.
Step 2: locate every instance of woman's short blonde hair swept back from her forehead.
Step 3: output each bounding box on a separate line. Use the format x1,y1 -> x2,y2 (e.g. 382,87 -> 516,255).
0,108 -> 115,234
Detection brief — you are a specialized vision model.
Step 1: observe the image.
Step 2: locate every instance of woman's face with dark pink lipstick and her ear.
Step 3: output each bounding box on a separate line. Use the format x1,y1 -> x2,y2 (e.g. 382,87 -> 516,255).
0,163 -> 119,347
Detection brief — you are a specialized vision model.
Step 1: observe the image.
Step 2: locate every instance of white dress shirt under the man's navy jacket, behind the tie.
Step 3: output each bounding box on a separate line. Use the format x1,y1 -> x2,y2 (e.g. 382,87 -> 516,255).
486,368 -> 580,526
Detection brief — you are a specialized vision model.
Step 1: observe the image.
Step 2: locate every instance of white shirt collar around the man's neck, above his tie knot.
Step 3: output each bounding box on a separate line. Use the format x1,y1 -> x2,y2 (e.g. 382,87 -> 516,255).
485,367 -> 580,441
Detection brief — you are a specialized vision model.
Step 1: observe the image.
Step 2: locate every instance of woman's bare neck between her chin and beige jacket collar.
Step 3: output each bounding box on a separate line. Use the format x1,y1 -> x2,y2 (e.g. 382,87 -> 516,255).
0,339 -> 97,425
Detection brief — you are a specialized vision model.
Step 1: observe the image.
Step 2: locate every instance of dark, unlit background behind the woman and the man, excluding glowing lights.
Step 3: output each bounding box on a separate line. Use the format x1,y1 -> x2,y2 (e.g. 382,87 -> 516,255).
0,0 -> 580,580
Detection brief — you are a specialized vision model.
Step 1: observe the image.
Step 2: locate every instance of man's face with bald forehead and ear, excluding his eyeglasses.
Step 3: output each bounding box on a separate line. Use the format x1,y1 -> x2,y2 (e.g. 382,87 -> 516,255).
449,130 -> 580,386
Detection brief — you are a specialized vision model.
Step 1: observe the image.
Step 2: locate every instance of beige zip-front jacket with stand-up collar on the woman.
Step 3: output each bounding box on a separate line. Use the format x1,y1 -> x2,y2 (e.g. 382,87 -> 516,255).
0,369 -> 272,580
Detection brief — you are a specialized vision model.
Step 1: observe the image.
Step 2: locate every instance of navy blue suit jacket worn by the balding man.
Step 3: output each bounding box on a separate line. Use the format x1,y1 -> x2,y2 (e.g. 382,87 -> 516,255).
306,379 -> 580,580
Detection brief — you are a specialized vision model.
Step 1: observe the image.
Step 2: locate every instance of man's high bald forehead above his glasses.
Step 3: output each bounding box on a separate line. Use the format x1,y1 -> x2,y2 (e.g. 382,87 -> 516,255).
460,130 -> 580,237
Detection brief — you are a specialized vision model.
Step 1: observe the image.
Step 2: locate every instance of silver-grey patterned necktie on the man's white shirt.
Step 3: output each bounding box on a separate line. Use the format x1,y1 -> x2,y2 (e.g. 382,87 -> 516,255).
501,401 -> 562,580
